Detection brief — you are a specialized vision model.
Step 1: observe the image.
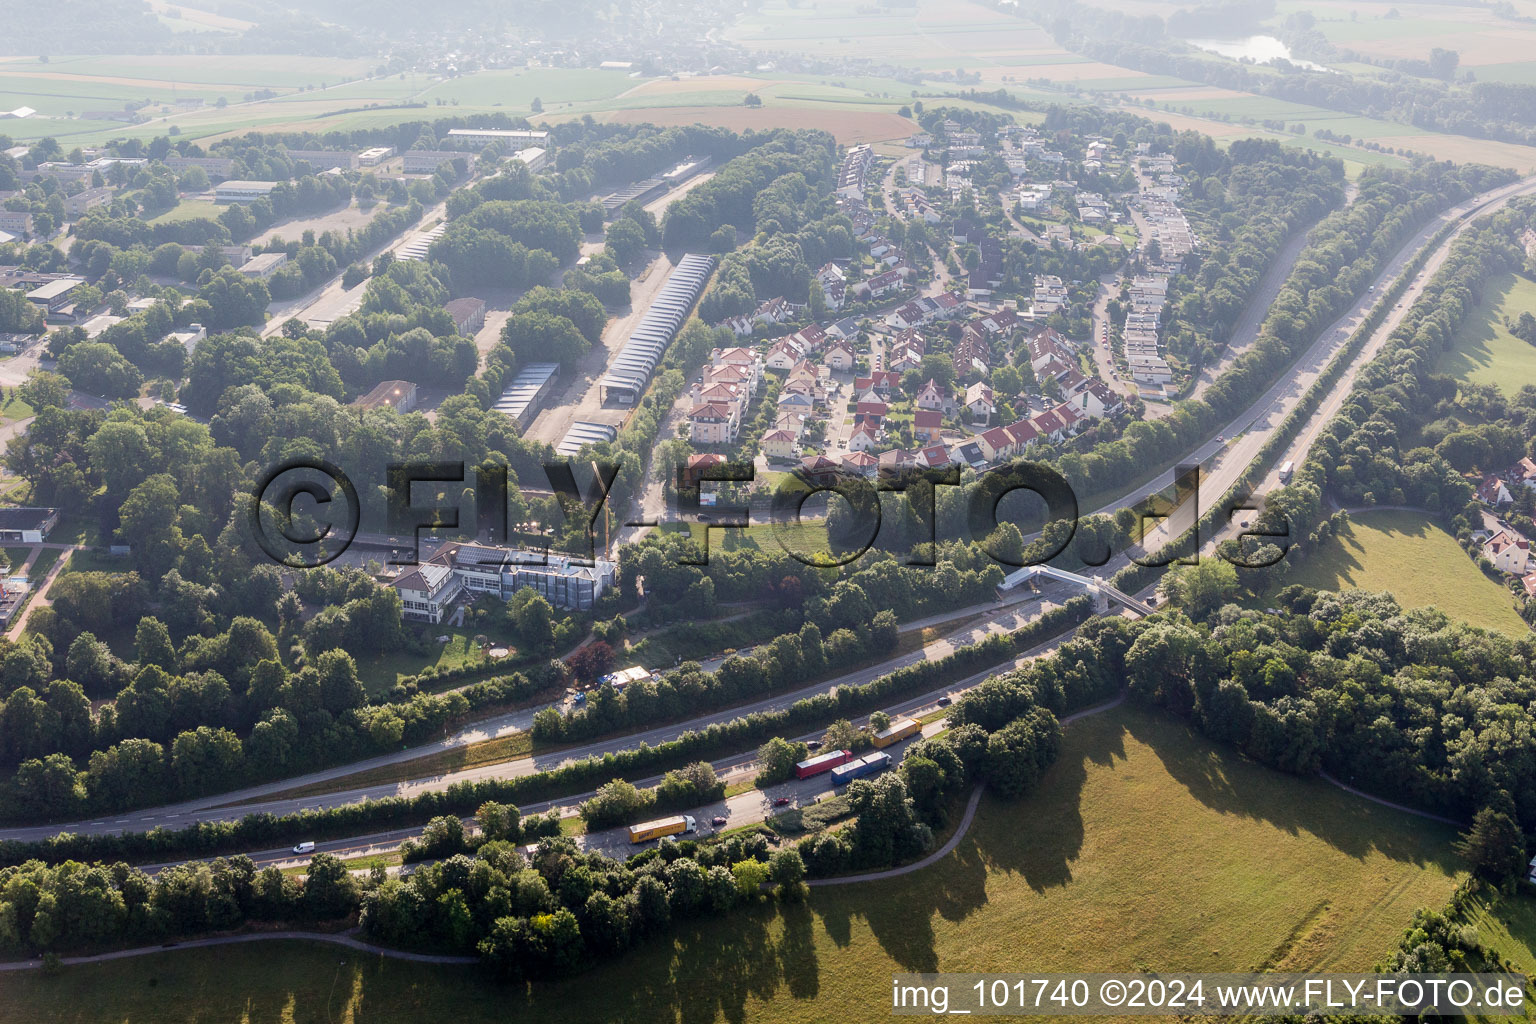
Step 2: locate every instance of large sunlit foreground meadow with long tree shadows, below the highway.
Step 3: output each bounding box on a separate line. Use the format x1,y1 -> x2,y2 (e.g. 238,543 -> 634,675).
0,709 -> 1459,1024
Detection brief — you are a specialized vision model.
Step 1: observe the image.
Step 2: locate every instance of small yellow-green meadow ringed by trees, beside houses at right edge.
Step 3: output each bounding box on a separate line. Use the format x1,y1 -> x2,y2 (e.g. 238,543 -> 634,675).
1284,511 -> 1528,636
